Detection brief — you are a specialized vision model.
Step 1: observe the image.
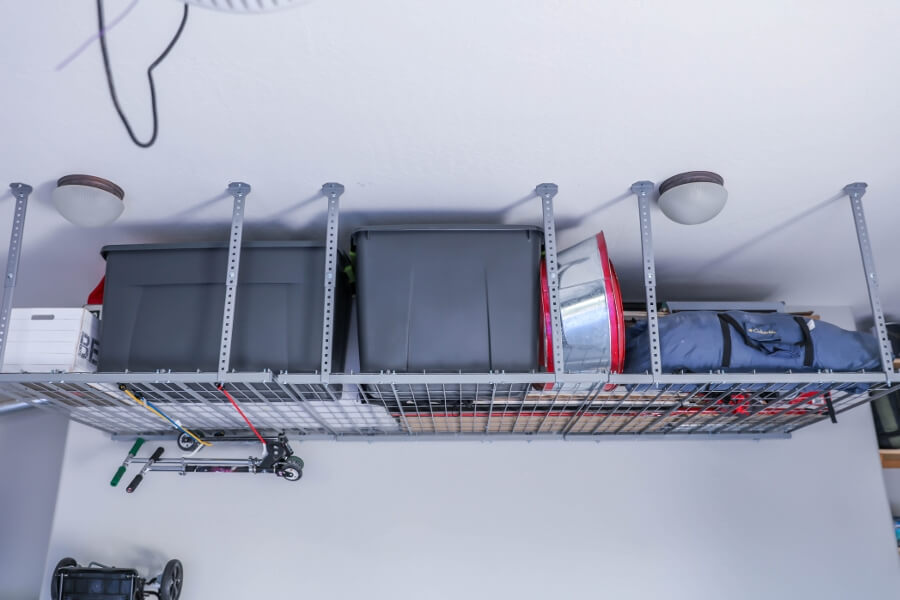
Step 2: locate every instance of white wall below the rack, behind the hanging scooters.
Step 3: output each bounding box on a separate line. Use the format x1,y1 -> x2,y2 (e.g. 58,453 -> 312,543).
44,407 -> 900,600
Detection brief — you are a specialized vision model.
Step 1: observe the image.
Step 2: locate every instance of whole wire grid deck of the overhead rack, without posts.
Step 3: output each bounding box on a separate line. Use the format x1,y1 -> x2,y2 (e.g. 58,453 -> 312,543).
0,380 -> 900,439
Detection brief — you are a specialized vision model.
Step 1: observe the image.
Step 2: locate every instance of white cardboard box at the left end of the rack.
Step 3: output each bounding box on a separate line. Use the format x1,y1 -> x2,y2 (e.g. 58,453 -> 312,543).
3,308 -> 100,373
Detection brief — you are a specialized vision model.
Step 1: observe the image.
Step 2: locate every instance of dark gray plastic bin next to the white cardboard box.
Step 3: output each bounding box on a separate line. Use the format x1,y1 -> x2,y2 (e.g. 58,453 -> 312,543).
99,242 -> 350,373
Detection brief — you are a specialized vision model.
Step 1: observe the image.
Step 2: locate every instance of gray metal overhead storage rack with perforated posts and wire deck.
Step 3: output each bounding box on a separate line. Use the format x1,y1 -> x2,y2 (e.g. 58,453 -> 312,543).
0,181 -> 900,441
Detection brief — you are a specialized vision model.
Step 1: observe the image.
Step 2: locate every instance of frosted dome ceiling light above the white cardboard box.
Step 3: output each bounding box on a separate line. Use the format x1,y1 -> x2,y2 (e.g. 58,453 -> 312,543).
53,175 -> 125,227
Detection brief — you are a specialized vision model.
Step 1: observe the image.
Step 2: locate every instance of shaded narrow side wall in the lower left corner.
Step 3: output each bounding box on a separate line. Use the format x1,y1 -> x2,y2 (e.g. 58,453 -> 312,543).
0,409 -> 68,600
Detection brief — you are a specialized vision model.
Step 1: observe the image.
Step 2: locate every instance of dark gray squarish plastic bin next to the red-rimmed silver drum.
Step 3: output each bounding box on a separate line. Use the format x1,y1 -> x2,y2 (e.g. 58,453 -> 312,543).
353,225 -> 543,373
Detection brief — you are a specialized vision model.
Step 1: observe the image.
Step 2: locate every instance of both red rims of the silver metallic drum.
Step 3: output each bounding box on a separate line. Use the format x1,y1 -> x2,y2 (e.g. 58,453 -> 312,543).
538,231 -> 625,373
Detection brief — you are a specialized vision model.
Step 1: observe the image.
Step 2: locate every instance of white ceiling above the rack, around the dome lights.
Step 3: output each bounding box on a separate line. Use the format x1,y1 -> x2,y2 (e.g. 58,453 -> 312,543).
0,0 -> 900,324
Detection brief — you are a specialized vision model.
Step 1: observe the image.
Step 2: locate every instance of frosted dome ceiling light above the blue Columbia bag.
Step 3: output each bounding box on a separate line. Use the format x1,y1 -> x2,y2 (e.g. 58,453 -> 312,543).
659,171 -> 728,225
